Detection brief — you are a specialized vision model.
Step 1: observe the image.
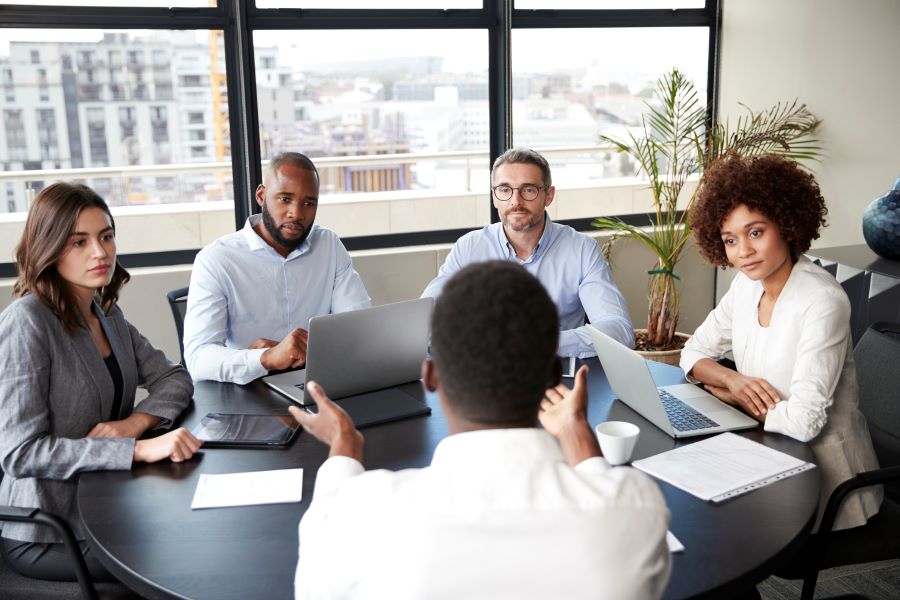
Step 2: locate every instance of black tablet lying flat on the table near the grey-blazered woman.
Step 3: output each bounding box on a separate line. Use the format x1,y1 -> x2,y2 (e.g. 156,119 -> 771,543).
191,413 -> 300,448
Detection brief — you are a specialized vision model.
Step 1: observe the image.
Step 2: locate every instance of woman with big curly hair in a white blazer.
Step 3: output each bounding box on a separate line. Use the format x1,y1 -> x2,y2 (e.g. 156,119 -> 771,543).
681,155 -> 882,529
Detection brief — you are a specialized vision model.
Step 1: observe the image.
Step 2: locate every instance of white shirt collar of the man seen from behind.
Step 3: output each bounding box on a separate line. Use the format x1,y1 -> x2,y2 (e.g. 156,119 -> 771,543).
431,427 -> 565,469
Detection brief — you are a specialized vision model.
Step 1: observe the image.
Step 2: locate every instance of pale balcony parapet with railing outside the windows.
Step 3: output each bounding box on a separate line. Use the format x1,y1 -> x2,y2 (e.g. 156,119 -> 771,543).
0,146 -> 693,263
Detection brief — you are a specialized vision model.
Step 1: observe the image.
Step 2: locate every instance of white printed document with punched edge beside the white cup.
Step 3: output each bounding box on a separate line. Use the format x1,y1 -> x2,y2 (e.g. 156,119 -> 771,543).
632,433 -> 815,502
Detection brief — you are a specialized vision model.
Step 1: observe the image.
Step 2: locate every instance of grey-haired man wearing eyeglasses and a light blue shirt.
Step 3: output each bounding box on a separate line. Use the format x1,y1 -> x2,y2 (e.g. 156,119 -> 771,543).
422,148 -> 634,358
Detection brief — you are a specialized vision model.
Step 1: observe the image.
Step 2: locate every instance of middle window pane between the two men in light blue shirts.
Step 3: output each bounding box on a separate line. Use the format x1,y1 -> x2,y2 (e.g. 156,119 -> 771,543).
254,30 -> 490,237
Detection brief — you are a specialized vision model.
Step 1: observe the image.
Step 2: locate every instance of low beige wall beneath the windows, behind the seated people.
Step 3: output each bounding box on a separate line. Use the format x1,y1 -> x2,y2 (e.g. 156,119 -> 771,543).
0,235 -> 715,360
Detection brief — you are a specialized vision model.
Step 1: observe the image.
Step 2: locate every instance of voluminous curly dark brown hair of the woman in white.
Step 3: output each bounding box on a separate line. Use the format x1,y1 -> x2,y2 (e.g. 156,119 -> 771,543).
690,154 -> 828,267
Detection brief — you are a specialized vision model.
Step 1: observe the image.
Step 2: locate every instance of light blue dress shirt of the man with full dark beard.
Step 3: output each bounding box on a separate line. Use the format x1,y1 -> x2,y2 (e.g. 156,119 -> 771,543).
184,215 -> 372,383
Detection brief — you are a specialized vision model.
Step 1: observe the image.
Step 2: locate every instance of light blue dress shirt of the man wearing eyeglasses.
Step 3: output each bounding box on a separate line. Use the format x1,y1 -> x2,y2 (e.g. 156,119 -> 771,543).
422,214 -> 634,358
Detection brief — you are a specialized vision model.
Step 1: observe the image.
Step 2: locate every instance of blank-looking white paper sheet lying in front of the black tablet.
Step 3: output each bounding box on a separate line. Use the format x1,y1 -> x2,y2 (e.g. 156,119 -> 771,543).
191,469 -> 303,509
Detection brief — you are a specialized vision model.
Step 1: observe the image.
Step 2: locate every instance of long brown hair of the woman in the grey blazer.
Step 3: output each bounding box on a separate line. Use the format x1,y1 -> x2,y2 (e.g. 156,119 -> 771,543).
13,183 -> 131,333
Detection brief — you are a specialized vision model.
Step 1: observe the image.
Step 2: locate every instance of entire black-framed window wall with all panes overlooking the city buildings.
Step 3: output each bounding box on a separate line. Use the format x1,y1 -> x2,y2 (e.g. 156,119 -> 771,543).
0,0 -> 718,276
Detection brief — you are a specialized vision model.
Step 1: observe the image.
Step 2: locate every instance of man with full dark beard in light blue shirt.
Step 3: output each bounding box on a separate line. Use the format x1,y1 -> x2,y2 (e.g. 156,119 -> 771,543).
184,152 -> 372,383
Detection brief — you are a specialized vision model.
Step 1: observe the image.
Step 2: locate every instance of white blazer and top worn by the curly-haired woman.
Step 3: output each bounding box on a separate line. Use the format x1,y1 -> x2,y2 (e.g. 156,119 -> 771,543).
681,257 -> 882,529
